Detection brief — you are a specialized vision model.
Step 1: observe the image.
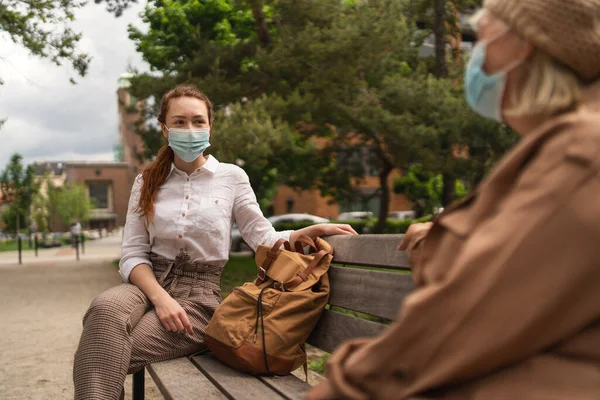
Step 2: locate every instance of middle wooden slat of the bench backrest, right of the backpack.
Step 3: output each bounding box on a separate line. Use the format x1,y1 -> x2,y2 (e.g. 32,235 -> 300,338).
329,267 -> 414,319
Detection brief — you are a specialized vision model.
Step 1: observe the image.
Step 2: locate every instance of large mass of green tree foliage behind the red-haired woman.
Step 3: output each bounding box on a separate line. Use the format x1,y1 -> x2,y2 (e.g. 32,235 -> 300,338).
125,0 -> 511,222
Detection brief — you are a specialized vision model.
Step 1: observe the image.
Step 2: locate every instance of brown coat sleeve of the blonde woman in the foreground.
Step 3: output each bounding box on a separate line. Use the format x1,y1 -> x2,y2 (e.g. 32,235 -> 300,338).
329,144 -> 600,398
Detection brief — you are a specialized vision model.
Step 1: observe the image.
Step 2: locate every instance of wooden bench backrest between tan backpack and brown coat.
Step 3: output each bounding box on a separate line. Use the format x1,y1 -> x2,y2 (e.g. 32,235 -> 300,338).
308,235 -> 413,353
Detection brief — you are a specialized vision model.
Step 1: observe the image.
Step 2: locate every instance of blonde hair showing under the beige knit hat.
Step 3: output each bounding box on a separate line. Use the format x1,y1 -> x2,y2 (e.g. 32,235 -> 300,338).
469,9 -> 586,116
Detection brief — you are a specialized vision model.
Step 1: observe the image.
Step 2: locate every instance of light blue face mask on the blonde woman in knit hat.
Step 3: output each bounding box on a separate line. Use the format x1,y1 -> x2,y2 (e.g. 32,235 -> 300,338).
465,32 -> 523,122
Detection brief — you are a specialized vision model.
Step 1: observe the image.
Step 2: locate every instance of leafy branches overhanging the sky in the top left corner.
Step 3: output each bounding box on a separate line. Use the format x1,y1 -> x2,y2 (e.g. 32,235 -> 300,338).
0,0 -> 90,83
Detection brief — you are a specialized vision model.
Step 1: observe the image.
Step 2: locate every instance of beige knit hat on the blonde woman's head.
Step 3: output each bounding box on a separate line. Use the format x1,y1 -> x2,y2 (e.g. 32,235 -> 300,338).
484,0 -> 600,81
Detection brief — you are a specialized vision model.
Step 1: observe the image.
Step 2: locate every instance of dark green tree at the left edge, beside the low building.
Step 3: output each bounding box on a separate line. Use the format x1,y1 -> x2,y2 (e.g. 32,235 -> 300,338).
0,154 -> 40,234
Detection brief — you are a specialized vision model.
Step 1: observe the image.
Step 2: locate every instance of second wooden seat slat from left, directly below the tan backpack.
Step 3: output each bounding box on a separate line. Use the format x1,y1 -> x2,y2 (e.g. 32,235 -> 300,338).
192,355 -> 284,400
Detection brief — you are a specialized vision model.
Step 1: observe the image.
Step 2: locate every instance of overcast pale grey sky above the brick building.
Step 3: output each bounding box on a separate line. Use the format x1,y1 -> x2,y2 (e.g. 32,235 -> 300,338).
0,1 -> 147,170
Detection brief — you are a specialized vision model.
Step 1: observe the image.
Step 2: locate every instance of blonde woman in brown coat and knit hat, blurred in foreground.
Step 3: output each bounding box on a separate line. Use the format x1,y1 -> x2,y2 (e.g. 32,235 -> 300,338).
308,0 -> 600,400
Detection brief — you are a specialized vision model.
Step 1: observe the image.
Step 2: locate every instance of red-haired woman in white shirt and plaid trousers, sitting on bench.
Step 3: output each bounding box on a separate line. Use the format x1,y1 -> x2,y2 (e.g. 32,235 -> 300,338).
73,85 -> 356,400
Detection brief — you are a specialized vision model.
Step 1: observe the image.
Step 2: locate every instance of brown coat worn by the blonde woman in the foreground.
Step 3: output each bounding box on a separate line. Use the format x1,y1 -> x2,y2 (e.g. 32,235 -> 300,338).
322,85 -> 600,400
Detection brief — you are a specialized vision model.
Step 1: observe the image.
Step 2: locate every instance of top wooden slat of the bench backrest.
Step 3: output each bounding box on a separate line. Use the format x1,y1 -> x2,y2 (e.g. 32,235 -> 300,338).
325,235 -> 409,269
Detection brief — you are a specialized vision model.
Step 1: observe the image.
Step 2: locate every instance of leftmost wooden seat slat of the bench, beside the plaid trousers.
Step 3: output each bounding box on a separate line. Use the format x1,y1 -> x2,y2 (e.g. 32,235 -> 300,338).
147,357 -> 227,400
